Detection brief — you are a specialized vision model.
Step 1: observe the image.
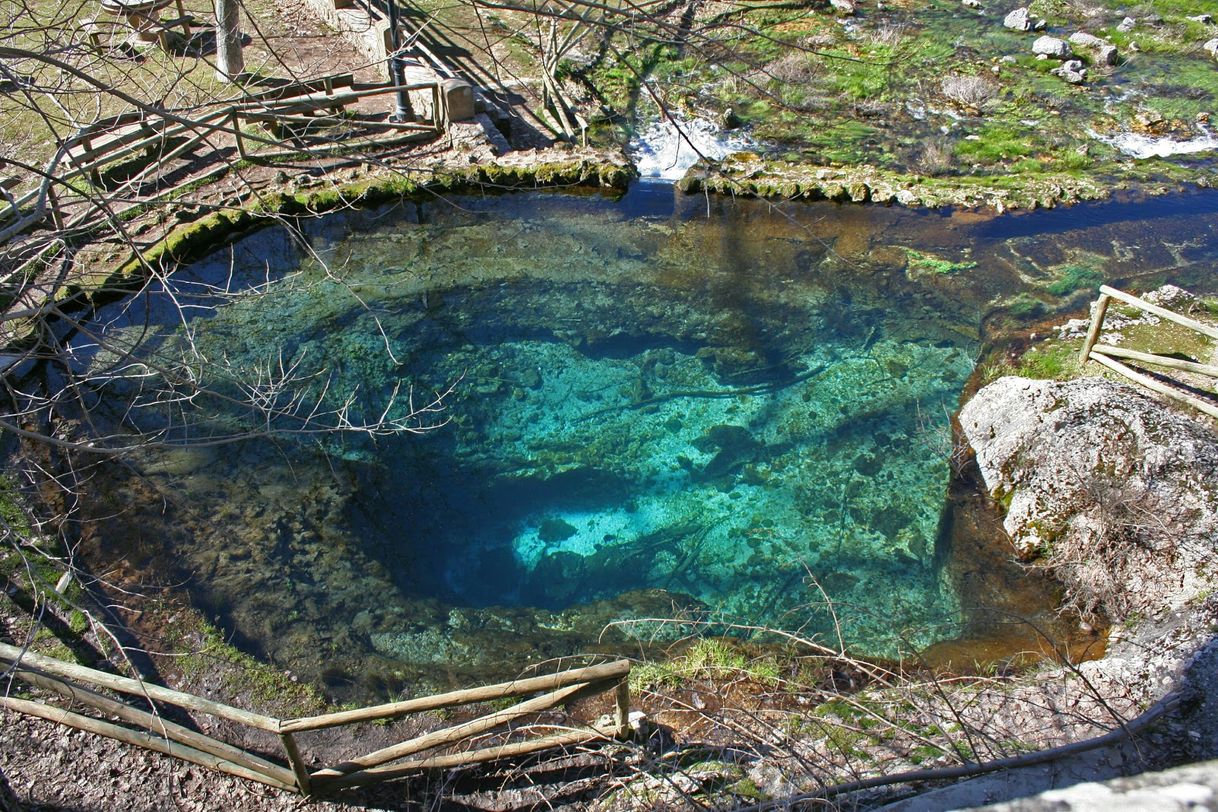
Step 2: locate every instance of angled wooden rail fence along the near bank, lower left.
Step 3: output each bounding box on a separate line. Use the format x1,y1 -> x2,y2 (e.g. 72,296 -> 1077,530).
0,643 -> 630,795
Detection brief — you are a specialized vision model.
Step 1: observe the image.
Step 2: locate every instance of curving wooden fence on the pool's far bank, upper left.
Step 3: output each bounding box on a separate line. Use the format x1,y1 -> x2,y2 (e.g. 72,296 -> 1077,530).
0,74 -> 448,240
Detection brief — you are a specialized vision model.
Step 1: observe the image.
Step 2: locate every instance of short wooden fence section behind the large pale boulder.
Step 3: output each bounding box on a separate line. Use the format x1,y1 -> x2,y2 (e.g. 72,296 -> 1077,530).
1079,285 -> 1218,418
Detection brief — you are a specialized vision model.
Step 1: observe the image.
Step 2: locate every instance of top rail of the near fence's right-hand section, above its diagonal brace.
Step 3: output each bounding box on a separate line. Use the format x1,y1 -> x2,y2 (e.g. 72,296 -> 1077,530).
280,660 -> 630,733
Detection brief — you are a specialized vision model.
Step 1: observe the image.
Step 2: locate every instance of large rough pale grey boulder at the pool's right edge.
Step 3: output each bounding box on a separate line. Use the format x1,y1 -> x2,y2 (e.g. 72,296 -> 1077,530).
960,377 -> 1218,618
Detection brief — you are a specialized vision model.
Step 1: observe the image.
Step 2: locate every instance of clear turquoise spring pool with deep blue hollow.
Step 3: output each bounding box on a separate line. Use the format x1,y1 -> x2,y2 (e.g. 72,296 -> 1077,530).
71,184 -> 1218,698
